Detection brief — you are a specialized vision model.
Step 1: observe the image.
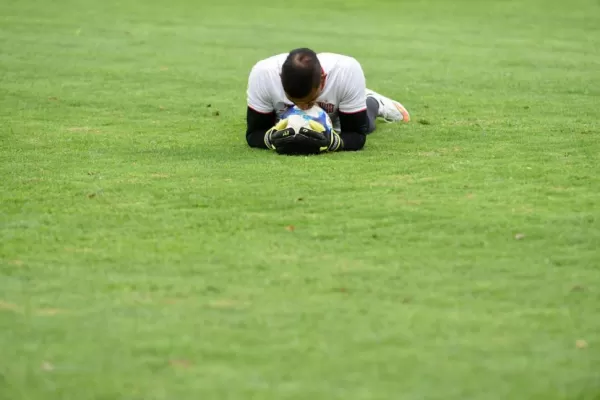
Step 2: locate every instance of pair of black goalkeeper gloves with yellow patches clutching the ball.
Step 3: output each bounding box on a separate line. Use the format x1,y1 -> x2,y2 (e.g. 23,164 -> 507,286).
265,120 -> 343,155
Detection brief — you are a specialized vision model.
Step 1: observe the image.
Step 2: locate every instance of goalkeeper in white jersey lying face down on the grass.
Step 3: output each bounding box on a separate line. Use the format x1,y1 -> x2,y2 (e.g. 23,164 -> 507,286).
246,49 -> 410,154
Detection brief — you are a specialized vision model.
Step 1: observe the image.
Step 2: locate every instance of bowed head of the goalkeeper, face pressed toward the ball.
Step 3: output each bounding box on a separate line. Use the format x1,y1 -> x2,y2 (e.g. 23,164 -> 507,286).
281,48 -> 325,109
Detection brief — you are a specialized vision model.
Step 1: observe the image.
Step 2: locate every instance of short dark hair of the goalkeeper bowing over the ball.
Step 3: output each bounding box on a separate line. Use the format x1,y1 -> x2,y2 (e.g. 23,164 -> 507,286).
281,48 -> 322,99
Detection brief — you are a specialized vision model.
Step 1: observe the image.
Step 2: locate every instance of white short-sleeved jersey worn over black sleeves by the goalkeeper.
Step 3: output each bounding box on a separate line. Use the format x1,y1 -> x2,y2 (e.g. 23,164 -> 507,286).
247,53 -> 367,130
